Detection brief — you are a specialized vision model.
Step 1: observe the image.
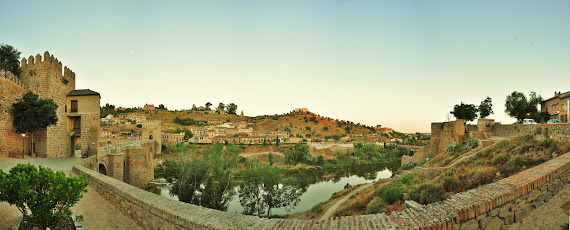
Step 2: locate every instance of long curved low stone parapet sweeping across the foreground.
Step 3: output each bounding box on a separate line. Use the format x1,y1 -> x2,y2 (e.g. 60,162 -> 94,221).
73,146 -> 570,229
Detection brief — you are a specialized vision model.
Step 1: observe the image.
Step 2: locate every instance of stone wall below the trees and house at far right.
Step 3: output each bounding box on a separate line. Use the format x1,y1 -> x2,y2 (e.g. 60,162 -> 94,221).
493,124 -> 570,140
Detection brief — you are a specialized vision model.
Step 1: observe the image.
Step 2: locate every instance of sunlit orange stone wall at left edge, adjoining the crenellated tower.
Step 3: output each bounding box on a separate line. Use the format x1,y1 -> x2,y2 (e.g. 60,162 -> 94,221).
0,70 -> 26,156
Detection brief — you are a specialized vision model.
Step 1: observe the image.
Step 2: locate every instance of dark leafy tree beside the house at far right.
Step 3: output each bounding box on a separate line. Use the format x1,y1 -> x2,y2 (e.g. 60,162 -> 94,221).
505,91 -> 542,120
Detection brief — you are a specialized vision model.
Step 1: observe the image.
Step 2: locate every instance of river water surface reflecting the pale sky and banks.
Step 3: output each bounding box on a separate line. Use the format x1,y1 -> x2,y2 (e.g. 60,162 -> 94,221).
155,162 -> 400,215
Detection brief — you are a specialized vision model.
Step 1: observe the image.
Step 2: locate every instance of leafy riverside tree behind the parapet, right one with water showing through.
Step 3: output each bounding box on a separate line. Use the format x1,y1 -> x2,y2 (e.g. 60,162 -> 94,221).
238,165 -> 302,218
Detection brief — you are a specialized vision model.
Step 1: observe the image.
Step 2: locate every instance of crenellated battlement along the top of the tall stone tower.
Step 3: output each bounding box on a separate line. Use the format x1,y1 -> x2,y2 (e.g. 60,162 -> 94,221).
20,51 -> 75,81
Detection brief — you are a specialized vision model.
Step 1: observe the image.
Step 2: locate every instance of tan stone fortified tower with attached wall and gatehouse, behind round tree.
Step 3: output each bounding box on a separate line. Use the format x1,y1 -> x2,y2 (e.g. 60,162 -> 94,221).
0,51 -> 100,157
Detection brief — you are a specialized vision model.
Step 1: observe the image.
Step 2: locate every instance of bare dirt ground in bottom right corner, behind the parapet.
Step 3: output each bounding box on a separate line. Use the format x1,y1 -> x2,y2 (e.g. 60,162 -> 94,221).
510,185 -> 570,230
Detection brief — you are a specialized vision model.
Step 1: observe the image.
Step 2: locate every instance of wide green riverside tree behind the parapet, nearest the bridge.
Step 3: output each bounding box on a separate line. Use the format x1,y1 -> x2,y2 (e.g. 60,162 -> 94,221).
155,143 -> 239,211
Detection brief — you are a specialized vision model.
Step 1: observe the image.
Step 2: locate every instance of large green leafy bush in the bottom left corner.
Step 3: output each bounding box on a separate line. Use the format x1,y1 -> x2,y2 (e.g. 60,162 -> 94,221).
0,164 -> 87,229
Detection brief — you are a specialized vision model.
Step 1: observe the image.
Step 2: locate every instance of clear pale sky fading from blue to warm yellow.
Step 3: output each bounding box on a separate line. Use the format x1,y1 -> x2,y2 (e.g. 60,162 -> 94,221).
0,0 -> 570,132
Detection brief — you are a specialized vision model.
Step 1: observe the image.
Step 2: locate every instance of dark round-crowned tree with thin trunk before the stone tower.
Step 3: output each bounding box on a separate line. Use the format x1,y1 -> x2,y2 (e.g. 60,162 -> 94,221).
10,91 -> 57,151
